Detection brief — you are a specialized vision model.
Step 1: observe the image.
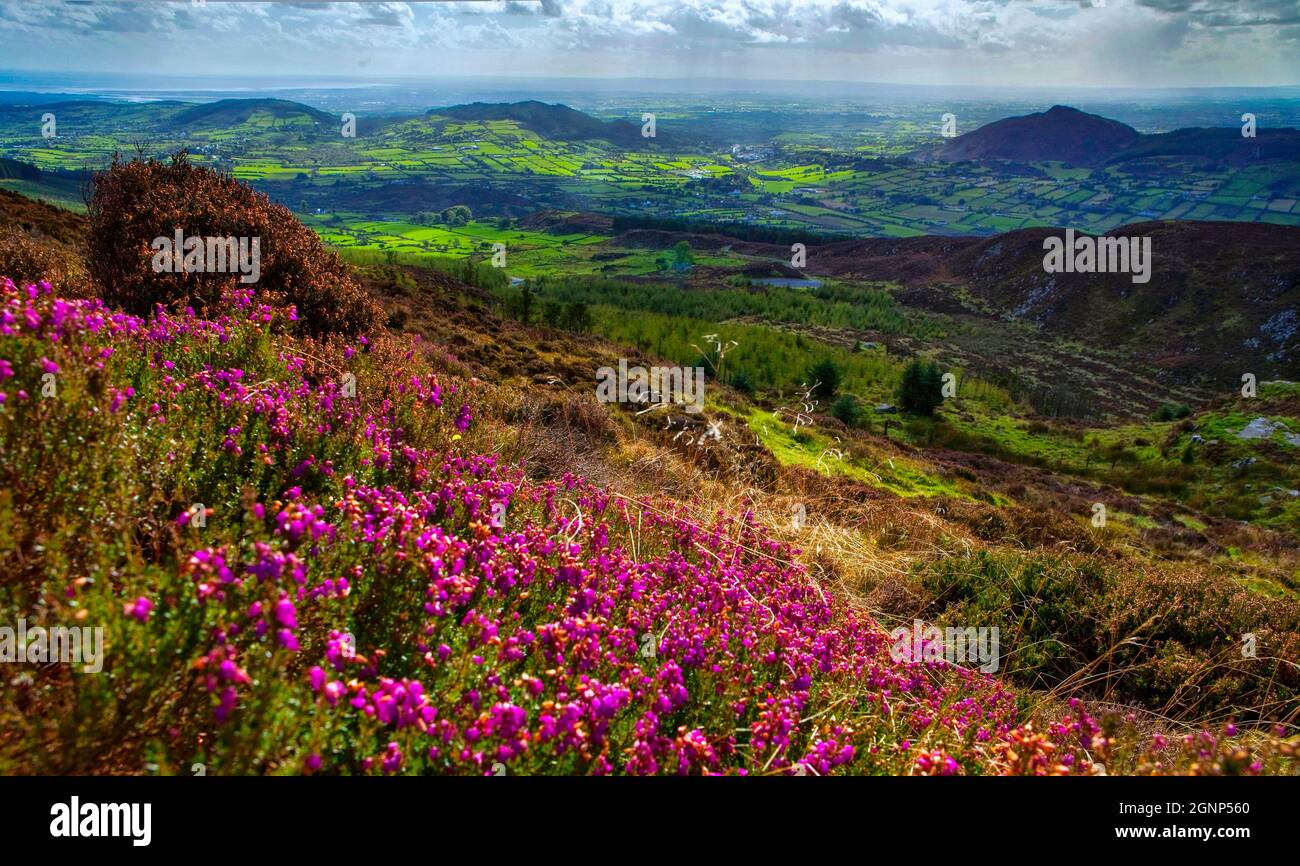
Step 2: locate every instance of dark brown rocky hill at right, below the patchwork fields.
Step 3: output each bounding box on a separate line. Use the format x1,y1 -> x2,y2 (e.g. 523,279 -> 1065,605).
809,222 -> 1300,385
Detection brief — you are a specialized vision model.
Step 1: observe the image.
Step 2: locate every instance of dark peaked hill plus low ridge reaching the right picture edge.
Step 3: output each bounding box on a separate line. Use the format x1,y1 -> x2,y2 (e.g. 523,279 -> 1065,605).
918,105 -> 1300,166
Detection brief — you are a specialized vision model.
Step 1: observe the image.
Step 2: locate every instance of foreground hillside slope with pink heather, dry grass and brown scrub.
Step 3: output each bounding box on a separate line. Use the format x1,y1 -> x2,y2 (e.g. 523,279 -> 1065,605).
0,183 -> 1300,775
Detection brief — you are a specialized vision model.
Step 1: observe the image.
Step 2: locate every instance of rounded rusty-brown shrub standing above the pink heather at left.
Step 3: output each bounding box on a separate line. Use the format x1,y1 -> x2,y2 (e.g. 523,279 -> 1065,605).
87,152 -> 380,335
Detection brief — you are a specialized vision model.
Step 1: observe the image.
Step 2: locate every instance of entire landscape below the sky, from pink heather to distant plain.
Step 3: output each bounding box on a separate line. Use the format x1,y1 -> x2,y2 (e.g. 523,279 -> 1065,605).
0,4 -> 1300,775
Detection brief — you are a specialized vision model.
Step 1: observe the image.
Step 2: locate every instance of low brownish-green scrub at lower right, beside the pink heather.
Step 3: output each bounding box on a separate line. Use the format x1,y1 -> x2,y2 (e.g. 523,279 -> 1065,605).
922,551 -> 1300,720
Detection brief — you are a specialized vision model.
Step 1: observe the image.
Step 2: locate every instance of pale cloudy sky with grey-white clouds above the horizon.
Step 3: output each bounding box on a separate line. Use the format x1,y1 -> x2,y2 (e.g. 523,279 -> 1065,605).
0,0 -> 1300,87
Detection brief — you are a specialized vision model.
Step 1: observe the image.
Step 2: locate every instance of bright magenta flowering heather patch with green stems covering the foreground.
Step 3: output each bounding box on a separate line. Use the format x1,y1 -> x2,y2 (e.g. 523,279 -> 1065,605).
0,281 -> 1294,775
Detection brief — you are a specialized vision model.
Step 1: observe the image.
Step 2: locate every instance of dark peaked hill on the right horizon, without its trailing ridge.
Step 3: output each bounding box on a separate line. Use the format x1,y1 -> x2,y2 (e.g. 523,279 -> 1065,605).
937,105 -> 1141,165
